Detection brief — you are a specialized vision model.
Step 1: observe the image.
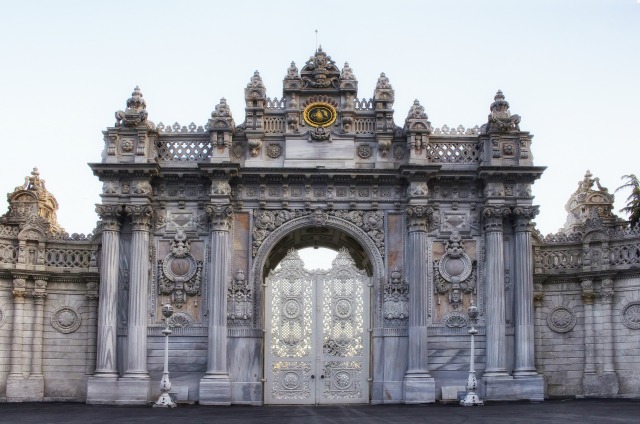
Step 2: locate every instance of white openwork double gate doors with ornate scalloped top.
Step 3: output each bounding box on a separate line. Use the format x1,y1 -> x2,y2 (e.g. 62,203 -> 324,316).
265,249 -> 370,404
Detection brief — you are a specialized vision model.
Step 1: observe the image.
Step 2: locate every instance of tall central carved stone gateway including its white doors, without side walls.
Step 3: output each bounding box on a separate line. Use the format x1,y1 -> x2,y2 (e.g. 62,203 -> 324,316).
81,49 -> 543,405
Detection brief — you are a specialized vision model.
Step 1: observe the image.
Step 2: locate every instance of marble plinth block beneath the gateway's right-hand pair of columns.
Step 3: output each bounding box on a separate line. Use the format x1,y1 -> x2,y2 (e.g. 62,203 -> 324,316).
481,375 -> 544,401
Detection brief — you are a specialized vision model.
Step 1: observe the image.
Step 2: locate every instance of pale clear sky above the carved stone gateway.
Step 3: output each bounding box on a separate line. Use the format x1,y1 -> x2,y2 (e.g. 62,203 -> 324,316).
0,0 -> 640,242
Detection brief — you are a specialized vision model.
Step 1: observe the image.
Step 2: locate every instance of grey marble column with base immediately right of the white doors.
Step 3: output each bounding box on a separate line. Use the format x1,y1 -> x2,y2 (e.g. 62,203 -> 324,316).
404,206 -> 435,403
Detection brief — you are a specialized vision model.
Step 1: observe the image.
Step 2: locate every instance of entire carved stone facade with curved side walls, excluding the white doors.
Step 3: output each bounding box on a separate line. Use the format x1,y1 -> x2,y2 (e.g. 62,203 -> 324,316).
0,49 -> 640,405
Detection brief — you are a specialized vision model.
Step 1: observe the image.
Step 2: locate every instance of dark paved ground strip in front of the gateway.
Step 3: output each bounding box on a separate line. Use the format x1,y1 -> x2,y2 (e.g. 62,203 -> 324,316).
0,399 -> 640,424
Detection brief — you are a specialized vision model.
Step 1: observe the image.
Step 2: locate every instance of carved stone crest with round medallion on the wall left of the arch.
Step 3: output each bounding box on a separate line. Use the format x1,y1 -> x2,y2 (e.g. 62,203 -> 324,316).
158,228 -> 202,308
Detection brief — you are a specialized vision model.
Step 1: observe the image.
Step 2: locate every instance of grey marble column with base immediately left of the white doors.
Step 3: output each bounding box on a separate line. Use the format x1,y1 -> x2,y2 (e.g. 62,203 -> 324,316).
200,204 -> 233,405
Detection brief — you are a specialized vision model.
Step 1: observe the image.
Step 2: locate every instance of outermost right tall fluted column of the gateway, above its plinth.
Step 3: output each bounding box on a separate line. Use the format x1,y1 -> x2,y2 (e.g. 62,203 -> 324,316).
513,206 -> 538,378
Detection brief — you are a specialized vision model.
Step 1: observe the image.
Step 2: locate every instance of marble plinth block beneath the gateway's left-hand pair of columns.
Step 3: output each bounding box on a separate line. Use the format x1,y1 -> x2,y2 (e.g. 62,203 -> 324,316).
87,376 -> 151,405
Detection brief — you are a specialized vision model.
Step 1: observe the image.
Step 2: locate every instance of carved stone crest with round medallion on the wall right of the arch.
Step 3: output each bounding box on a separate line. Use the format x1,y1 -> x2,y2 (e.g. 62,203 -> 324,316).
434,232 -> 476,309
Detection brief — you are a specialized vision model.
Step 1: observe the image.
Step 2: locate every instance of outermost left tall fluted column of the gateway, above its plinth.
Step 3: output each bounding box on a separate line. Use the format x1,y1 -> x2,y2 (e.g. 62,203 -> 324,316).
93,205 -> 122,378
